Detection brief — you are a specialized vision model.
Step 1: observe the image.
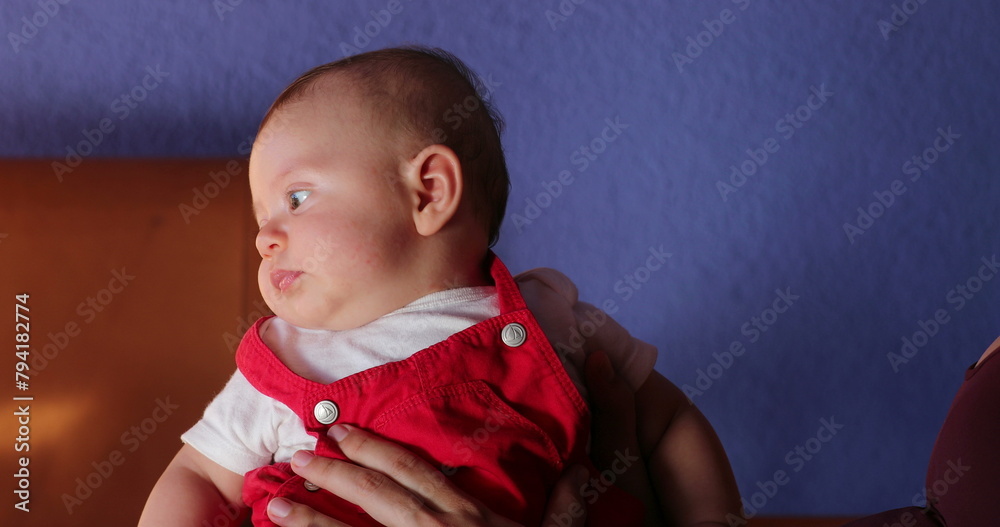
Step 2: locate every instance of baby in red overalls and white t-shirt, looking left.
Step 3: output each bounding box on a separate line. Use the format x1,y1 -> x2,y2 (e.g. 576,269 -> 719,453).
140,48 -> 739,526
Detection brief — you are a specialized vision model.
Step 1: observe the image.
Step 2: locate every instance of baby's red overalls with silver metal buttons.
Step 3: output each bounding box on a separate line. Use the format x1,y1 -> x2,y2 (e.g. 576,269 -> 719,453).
236,253 -> 642,527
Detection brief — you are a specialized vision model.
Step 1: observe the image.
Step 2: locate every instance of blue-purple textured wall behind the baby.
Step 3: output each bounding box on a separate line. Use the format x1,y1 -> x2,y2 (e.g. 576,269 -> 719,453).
0,0 -> 1000,515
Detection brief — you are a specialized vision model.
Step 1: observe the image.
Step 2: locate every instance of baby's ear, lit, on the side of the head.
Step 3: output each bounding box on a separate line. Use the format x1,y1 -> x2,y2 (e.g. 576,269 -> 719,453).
405,144 -> 462,236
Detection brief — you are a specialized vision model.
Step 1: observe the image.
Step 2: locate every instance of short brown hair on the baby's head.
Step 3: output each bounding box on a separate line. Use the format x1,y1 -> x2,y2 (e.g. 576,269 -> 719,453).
258,46 -> 510,247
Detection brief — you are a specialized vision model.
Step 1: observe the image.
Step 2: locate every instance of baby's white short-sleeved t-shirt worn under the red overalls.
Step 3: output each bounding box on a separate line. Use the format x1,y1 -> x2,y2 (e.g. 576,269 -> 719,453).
181,269 -> 656,474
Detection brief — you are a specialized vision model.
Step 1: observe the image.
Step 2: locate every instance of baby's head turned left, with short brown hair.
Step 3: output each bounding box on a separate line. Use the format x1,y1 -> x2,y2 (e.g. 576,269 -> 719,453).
250,48 -> 510,330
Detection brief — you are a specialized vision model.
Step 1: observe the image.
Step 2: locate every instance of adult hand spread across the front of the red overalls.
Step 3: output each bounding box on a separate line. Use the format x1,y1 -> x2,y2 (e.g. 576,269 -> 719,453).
267,425 -> 587,527
